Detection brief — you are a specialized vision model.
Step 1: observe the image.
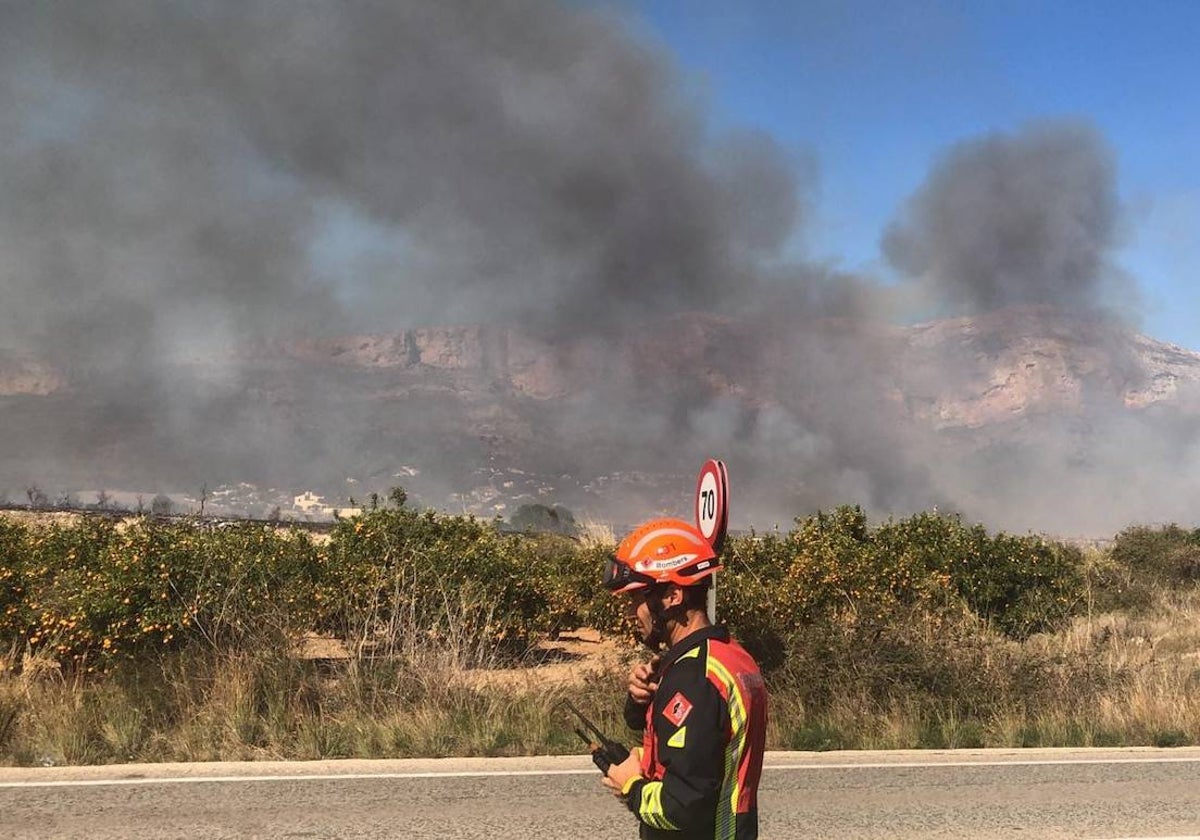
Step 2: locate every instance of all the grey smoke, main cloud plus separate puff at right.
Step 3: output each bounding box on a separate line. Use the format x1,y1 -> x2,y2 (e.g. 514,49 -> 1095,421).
0,0 -> 1192,537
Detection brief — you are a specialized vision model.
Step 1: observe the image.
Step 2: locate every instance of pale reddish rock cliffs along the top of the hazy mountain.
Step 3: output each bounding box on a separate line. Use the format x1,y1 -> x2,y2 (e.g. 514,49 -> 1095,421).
258,307 -> 1200,428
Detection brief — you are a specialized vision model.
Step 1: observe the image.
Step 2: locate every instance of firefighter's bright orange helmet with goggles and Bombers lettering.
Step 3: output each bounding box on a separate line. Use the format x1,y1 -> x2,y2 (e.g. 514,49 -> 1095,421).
604,520 -> 721,593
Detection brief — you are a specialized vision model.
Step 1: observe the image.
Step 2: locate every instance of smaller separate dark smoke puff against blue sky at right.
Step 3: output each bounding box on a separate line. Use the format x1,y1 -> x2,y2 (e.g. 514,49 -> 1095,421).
883,122 -> 1121,314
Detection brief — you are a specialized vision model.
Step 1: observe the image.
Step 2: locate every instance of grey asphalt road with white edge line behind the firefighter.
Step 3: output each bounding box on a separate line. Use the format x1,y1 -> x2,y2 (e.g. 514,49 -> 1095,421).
0,749 -> 1200,840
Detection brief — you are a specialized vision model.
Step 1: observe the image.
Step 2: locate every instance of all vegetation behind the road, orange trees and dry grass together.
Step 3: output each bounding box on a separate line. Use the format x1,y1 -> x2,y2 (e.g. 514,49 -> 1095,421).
0,491 -> 1200,764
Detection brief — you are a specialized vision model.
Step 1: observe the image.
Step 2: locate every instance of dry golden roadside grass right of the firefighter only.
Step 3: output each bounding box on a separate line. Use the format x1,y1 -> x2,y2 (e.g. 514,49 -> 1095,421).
772,592 -> 1200,749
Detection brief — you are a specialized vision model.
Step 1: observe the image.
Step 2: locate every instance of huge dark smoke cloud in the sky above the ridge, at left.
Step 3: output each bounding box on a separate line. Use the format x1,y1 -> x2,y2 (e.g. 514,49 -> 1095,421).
0,0 -> 798,350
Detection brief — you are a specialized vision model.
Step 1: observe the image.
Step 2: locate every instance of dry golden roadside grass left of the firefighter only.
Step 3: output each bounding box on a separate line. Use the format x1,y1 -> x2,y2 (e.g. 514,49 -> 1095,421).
0,652 -> 623,764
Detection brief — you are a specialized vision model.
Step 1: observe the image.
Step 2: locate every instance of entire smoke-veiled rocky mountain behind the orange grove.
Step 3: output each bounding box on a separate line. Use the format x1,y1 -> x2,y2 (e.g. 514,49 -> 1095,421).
7,307 -> 1200,530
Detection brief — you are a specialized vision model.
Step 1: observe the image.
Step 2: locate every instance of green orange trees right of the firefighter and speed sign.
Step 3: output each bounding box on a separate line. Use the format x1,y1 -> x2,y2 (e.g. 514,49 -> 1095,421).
720,506 -> 1082,661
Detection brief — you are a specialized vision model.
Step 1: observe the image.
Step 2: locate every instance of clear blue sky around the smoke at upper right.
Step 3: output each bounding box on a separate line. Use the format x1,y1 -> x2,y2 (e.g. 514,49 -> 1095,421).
625,0 -> 1200,349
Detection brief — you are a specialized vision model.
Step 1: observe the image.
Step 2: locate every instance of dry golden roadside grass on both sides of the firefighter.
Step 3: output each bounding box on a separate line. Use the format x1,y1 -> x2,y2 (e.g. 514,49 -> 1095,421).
0,580 -> 1200,764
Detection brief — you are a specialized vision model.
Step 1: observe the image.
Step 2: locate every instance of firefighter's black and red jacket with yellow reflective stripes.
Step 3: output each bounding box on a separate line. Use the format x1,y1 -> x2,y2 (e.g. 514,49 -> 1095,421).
625,626 -> 767,840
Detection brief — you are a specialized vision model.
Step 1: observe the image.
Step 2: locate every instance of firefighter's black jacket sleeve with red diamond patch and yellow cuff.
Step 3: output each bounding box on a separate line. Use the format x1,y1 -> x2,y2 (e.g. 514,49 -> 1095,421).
626,658 -> 728,829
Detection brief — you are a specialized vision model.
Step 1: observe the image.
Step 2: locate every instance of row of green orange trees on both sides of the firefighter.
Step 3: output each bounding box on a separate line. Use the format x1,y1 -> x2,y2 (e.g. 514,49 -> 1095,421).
0,499 -> 1099,684
